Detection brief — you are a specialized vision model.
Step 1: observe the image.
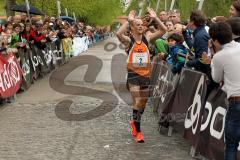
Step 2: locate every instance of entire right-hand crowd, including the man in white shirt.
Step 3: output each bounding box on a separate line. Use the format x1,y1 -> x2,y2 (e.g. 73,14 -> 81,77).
130,0 -> 240,160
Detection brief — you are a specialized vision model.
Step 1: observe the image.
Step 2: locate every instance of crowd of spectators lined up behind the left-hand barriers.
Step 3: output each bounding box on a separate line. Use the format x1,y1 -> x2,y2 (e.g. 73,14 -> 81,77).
0,13 -> 109,56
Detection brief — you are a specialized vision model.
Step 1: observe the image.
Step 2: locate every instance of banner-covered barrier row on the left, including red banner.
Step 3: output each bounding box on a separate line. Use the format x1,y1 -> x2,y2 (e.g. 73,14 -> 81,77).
0,34 -> 105,99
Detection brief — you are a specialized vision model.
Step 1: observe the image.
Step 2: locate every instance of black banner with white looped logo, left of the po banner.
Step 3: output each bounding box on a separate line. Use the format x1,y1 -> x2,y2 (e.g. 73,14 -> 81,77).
171,68 -> 207,147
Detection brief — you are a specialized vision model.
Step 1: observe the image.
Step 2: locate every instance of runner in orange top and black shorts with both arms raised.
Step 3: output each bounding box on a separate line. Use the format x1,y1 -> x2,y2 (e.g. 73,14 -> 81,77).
116,8 -> 167,143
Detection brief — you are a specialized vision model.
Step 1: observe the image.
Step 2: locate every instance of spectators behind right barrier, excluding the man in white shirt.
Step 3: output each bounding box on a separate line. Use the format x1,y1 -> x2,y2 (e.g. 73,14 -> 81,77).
139,0 -> 240,77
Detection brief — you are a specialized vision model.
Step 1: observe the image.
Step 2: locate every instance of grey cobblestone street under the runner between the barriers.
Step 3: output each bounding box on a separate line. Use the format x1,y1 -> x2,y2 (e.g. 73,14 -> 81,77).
0,39 -> 191,160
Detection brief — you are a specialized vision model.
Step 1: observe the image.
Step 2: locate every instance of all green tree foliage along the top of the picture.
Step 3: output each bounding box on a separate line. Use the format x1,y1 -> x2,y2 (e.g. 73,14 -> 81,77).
0,0 -> 232,25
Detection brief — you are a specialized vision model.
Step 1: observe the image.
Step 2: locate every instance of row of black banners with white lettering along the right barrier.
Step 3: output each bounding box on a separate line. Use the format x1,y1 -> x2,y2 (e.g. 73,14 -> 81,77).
153,67 -> 240,160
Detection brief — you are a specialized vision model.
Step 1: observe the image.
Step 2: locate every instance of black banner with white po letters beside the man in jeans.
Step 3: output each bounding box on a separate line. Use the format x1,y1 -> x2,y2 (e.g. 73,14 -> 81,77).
197,88 -> 240,160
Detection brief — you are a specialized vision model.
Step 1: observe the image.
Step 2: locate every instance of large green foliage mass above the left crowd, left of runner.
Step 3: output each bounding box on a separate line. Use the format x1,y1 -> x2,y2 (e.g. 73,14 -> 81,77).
17,0 -> 123,25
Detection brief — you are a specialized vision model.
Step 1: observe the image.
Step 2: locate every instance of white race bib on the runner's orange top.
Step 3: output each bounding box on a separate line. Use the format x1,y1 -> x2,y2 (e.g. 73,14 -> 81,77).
132,53 -> 148,67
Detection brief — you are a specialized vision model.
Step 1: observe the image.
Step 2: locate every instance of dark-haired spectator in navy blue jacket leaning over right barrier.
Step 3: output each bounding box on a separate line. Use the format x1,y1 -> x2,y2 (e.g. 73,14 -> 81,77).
183,11 -> 218,99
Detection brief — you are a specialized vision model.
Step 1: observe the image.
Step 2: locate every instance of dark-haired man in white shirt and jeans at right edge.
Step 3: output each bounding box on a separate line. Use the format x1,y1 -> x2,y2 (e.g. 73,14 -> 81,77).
209,22 -> 240,160
